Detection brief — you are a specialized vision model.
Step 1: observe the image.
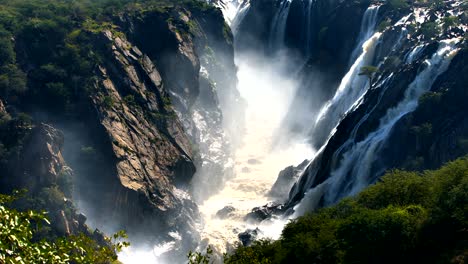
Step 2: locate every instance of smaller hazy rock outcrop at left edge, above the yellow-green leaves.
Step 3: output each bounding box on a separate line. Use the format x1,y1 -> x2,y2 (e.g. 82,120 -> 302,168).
0,101 -> 97,241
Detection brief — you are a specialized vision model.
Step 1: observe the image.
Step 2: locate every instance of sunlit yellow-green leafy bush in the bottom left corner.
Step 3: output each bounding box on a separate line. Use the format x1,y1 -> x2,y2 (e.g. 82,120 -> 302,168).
0,191 -> 129,264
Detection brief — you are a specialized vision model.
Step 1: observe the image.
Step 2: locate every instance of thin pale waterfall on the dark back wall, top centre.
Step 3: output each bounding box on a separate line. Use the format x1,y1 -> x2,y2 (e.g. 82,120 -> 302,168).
269,0 -> 292,52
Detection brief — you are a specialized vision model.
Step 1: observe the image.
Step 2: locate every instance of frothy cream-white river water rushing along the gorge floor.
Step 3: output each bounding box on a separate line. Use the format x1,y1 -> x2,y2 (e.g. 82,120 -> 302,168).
200,54 -> 313,251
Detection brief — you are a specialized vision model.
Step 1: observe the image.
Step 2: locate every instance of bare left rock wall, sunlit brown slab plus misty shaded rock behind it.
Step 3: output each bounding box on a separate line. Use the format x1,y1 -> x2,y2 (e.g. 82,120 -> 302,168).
55,3 -> 239,255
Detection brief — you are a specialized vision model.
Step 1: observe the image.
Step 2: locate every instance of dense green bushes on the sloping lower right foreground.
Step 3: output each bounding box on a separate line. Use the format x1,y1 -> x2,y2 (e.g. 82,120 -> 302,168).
225,158 -> 468,263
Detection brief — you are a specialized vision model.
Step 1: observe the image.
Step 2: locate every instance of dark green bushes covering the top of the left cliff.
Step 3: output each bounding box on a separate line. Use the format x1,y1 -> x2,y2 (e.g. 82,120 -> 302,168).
0,0 -> 215,115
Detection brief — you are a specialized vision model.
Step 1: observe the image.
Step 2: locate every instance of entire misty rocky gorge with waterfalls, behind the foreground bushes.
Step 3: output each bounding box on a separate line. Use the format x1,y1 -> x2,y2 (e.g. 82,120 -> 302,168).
0,0 -> 468,263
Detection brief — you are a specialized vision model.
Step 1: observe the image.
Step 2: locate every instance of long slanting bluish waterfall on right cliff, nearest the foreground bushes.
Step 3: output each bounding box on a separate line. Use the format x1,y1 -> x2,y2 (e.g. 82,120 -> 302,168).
325,39 -> 459,203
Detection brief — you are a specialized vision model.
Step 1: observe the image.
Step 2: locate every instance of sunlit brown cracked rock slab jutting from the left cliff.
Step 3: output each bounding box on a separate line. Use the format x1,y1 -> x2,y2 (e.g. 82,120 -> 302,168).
82,27 -> 196,244
